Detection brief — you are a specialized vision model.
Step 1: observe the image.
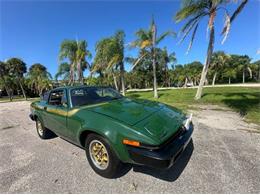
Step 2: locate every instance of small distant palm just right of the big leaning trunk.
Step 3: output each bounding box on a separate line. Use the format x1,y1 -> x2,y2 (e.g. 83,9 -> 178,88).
210,51 -> 230,85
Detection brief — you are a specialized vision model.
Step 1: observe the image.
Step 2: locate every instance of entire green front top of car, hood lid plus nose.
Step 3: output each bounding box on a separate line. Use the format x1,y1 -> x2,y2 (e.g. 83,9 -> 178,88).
85,98 -> 185,143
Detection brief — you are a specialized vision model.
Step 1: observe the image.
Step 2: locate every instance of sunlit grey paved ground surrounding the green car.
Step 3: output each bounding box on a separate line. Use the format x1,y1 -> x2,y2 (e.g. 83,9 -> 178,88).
0,102 -> 260,193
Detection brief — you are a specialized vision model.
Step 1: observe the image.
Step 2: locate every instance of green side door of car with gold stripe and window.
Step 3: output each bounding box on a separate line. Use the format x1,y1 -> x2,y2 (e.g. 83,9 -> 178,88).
44,89 -> 68,137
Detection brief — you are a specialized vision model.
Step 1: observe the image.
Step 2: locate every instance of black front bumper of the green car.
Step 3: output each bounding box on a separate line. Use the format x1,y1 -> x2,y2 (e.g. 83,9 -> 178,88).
127,123 -> 193,169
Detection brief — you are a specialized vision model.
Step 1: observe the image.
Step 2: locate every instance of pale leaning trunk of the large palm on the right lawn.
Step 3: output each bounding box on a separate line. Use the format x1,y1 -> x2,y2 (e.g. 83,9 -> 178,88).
195,17 -> 215,100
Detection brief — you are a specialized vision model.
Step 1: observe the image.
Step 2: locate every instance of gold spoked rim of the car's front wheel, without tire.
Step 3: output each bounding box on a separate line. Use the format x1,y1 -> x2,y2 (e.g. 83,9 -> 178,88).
89,140 -> 109,170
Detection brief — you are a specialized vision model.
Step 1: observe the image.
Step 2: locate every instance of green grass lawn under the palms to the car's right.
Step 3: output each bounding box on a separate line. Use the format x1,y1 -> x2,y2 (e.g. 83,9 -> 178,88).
127,87 -> 260,125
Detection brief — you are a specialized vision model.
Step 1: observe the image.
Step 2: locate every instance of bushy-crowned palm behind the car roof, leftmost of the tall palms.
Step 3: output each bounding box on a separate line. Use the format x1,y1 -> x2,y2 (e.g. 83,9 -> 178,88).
59,40 -> 91,85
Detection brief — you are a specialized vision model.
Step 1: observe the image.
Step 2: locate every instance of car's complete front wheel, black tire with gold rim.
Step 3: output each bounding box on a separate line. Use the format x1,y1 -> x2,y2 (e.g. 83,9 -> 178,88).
85,134 -> 122,178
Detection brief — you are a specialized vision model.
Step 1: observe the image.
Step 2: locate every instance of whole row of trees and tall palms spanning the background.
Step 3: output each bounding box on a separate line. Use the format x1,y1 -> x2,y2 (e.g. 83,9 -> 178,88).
0,0 -> 254,99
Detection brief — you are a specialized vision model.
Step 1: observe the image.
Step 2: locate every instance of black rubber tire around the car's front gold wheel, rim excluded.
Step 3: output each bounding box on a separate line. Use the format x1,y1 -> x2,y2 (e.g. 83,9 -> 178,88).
85,134 -> 123,178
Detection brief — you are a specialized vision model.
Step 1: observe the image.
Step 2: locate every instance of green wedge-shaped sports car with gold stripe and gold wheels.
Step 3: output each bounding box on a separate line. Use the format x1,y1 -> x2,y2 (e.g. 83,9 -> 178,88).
30,86 -> 193,178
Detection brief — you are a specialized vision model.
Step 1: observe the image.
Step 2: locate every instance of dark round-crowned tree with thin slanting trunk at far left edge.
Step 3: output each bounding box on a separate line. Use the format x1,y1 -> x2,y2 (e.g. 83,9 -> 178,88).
6,58 -> 27,100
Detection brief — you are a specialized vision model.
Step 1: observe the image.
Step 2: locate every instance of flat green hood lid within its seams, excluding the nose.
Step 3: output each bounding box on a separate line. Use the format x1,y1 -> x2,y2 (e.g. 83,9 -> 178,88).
88,98 -> 162,126
